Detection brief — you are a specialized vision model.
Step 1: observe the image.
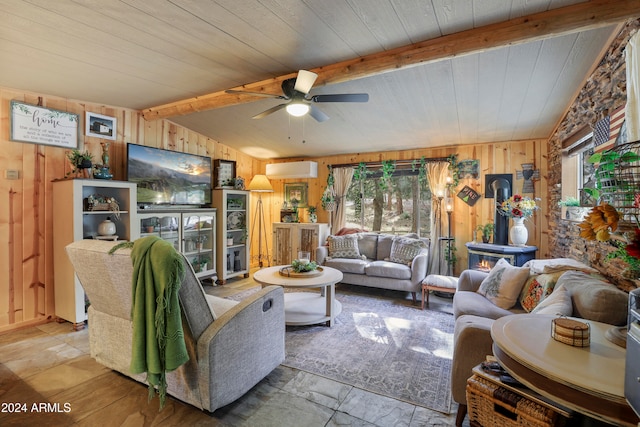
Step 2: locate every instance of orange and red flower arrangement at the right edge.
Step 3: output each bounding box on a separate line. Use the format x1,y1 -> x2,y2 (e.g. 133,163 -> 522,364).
578,198 -> 640,279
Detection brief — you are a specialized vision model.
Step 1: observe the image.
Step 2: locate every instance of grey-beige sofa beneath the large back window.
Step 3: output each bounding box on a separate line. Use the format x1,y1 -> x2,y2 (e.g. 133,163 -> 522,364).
316,232 -> 429,303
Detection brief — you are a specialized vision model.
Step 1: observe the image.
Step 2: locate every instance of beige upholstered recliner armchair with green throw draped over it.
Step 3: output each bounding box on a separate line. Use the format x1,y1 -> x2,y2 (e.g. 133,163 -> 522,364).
66,240 -> 285,412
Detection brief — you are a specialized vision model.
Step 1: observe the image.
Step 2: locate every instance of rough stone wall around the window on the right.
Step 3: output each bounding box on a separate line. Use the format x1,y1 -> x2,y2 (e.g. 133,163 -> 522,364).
547,19 -> 640,290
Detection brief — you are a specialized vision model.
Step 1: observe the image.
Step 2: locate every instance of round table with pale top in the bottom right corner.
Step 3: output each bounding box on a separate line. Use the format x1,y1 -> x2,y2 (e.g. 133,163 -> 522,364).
491,314 -> 638,426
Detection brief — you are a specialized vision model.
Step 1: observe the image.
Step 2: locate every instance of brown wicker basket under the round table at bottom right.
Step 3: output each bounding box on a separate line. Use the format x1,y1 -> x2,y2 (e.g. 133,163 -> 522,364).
467,375 -> 564,427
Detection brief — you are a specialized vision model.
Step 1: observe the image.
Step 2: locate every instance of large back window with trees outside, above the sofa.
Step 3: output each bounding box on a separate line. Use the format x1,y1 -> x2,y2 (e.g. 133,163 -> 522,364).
345,161 -> 431,237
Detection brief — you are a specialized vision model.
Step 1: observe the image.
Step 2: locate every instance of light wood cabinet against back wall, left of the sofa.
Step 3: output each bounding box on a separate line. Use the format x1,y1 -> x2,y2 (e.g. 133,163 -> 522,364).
273,222 -> 329,265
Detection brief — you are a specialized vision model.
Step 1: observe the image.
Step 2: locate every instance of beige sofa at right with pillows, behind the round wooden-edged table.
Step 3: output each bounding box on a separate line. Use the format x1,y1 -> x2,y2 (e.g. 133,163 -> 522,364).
451,259 -> 629,426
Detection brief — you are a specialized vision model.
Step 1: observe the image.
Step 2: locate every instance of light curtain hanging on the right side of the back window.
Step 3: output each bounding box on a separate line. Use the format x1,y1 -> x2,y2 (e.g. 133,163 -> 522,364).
425,162 -> 449,274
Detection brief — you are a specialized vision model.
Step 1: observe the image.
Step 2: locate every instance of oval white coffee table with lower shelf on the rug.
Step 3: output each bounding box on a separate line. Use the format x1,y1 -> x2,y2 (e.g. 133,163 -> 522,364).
253,265 -> 342,327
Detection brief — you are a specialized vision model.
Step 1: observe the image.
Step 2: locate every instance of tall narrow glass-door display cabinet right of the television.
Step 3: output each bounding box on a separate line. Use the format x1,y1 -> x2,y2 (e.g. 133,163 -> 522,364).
213,189 -> 251,285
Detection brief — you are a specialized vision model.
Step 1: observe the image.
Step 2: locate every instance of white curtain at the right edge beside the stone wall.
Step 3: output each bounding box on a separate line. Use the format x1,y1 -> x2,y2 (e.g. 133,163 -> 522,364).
624,31 -> 640,142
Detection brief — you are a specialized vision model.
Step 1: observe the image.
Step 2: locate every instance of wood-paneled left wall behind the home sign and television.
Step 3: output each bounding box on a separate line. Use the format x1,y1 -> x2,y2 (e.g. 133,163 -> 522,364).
0,88 -> 263,332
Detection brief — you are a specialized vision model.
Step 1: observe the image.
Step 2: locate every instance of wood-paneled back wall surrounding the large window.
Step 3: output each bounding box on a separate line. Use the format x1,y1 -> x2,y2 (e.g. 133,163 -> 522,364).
263,140 -> 549,274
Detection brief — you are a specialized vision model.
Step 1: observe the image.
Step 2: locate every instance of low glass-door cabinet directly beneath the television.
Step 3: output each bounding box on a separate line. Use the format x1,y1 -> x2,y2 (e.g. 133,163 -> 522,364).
138,208 -> 217,281
